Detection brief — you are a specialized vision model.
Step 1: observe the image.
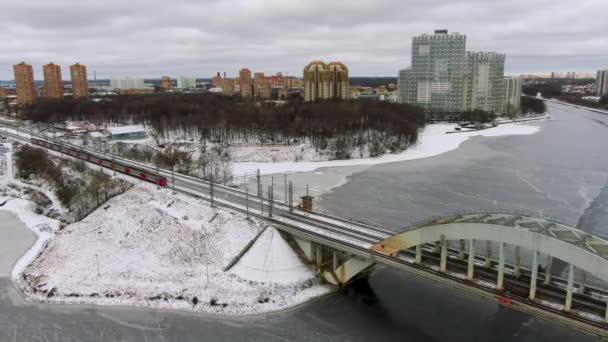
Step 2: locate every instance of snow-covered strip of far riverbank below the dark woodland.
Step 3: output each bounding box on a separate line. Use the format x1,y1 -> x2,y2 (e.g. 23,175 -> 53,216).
233,123 -> 540,175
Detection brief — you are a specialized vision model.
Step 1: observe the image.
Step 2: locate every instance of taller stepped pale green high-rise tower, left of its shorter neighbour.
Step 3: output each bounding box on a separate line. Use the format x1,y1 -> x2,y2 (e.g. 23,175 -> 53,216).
399,30 -> 467,113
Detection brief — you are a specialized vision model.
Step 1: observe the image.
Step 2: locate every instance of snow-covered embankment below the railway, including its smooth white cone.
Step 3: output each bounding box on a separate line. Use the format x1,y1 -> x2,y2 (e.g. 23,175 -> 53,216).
13,184 -> 331,315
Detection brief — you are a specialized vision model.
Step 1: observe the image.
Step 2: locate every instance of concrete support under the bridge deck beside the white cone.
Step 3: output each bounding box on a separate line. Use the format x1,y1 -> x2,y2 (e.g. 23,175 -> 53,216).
293,236 -> 375,287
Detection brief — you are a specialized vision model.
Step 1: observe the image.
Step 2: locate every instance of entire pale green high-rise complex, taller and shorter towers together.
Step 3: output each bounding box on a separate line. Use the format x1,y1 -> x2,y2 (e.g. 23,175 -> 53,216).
399,30 -> 505,119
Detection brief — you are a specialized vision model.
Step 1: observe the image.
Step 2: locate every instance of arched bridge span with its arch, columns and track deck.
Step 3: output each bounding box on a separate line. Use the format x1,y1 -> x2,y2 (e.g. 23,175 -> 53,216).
366,213 -> 608,337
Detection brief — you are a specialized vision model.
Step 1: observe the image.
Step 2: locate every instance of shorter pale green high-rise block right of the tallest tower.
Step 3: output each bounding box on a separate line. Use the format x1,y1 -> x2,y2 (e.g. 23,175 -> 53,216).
464,52 -> 505,113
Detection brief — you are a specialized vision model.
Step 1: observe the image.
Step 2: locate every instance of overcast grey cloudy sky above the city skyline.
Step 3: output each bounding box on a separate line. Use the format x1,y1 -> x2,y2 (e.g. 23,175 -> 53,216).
0,0 -> 608,80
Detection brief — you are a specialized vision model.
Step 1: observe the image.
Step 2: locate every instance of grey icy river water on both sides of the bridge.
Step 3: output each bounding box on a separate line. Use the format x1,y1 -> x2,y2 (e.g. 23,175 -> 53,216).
0,104 -> 608,341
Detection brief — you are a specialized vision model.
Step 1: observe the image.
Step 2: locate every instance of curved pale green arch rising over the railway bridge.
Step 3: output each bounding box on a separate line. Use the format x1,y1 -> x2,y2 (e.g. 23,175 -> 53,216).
372,212 -> 608,283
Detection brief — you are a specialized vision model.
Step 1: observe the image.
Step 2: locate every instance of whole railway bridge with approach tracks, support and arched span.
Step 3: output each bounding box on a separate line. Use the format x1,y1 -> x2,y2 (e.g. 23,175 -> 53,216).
0,124 -> 608,338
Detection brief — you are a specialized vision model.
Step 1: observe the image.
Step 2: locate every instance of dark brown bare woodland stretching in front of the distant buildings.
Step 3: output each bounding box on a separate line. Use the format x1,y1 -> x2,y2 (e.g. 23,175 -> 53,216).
30,94 -> 425,155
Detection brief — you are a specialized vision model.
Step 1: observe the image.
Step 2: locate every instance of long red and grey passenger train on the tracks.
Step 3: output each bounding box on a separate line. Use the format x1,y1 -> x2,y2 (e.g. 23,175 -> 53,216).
31,138 -> 168,187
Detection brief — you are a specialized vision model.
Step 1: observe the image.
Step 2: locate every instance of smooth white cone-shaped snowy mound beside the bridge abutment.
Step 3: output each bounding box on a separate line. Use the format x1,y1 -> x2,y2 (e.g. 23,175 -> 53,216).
230,227 -> 315,284
